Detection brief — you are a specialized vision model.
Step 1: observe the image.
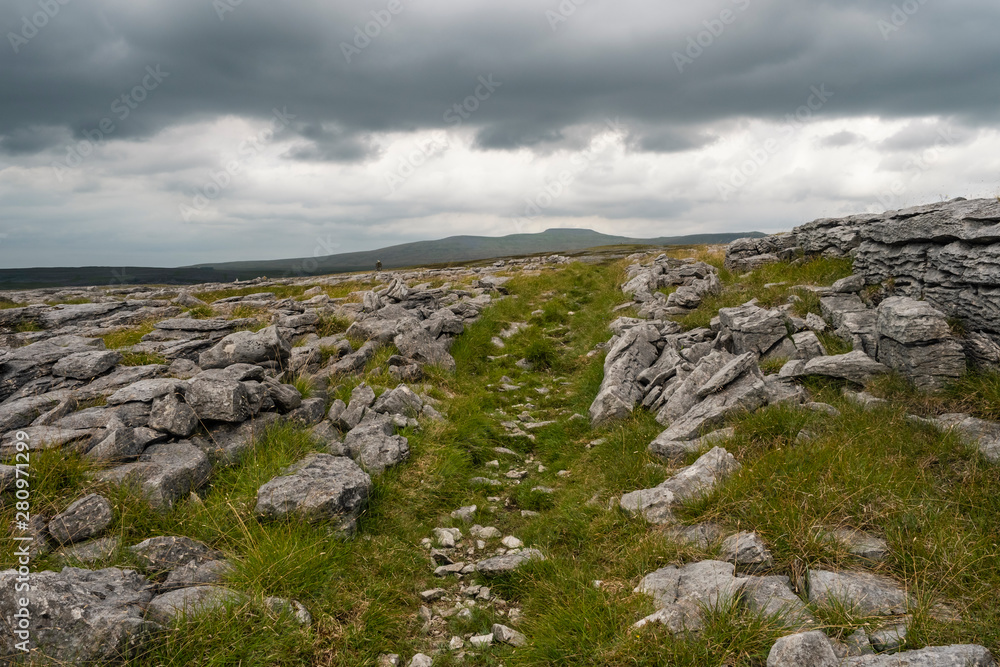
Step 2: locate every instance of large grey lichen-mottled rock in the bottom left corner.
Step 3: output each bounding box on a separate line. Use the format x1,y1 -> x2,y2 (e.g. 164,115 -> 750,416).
0,567 -> 153,665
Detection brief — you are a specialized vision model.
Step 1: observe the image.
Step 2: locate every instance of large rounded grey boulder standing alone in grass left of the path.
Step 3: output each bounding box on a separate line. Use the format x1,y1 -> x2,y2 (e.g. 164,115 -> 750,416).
256,454 -> 372,530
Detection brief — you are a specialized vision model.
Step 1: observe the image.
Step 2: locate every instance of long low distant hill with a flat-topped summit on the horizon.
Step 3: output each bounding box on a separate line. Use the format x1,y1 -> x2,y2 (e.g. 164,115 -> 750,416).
0,229 -> 764,289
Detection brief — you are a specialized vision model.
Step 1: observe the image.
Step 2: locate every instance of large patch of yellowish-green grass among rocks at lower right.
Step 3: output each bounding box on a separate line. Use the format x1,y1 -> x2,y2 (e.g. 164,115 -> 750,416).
685,396 -> 1000,650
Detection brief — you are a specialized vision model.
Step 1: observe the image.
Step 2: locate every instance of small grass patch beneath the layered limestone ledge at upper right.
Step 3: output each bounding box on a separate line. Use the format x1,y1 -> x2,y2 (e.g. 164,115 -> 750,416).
677,252 -> 852,329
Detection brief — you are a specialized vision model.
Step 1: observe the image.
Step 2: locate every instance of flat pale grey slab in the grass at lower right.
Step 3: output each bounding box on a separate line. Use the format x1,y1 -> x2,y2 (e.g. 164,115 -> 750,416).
808,570 -> 910,616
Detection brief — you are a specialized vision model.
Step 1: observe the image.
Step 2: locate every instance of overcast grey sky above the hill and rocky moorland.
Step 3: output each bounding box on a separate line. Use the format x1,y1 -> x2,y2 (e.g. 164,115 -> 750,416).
0,0 -> 1000,268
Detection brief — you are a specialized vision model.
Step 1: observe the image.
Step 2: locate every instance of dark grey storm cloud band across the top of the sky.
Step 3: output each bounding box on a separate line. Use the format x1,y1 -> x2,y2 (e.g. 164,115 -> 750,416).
0,0 -> 1000,161
